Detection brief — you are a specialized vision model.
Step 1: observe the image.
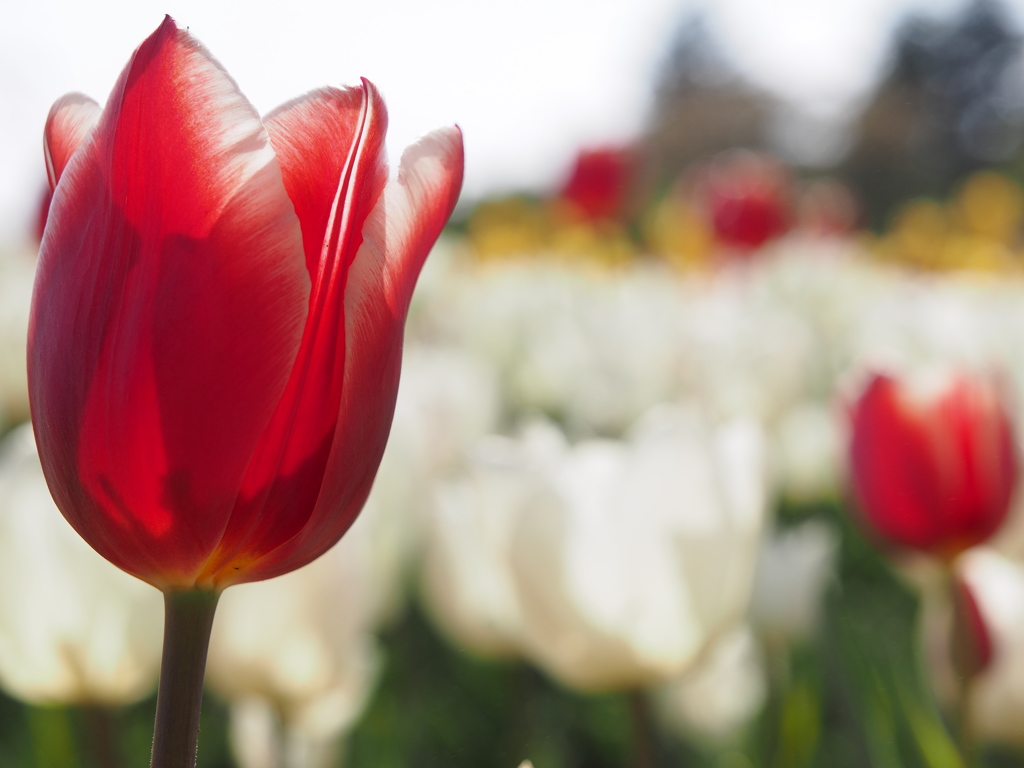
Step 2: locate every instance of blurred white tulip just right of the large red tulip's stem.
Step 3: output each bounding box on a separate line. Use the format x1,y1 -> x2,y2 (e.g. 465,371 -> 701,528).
206,517 -> 378,765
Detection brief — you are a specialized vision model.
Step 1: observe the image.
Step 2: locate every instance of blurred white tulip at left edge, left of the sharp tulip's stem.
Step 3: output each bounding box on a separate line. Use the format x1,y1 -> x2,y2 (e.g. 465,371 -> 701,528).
0,424 -> 163,705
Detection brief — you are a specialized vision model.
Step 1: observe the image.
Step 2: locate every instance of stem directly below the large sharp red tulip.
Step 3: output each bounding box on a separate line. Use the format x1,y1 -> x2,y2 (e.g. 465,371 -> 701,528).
150,590 -> 220,768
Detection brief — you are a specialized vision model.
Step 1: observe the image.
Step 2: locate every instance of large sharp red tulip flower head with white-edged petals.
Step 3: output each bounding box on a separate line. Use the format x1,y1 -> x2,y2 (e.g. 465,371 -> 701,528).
29,18 -> 463,591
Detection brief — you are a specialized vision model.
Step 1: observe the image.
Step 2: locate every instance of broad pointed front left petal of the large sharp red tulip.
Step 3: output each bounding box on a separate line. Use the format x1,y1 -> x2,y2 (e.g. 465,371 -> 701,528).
29,17 -> 309,588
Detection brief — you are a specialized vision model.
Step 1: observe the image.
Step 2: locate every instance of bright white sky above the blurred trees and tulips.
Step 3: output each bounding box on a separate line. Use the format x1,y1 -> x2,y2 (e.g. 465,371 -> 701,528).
0,0 -> 1007,242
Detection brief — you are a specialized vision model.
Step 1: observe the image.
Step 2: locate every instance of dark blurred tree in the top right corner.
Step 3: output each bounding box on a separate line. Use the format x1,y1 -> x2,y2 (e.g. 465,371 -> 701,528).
839,0 -> 1024,227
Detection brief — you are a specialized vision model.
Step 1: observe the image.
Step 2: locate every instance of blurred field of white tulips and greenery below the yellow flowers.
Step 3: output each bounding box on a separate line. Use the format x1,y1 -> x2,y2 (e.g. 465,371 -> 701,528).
6,218 -> 1024,766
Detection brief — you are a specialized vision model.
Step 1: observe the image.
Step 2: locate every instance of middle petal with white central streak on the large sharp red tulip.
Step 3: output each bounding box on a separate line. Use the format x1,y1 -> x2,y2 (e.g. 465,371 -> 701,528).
196,81 -> 387,580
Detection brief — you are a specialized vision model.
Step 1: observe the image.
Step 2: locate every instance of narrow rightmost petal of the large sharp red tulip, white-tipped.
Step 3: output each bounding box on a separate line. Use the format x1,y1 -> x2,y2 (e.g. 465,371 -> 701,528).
234,127 -> 463,581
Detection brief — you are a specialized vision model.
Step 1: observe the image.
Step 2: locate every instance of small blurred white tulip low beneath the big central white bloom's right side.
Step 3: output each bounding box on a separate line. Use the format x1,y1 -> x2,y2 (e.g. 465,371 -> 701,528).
657,626 -> 768,740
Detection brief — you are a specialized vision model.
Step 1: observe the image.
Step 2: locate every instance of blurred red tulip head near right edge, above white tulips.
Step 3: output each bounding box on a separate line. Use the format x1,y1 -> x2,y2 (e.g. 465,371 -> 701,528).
850,375 -> 1018,557
